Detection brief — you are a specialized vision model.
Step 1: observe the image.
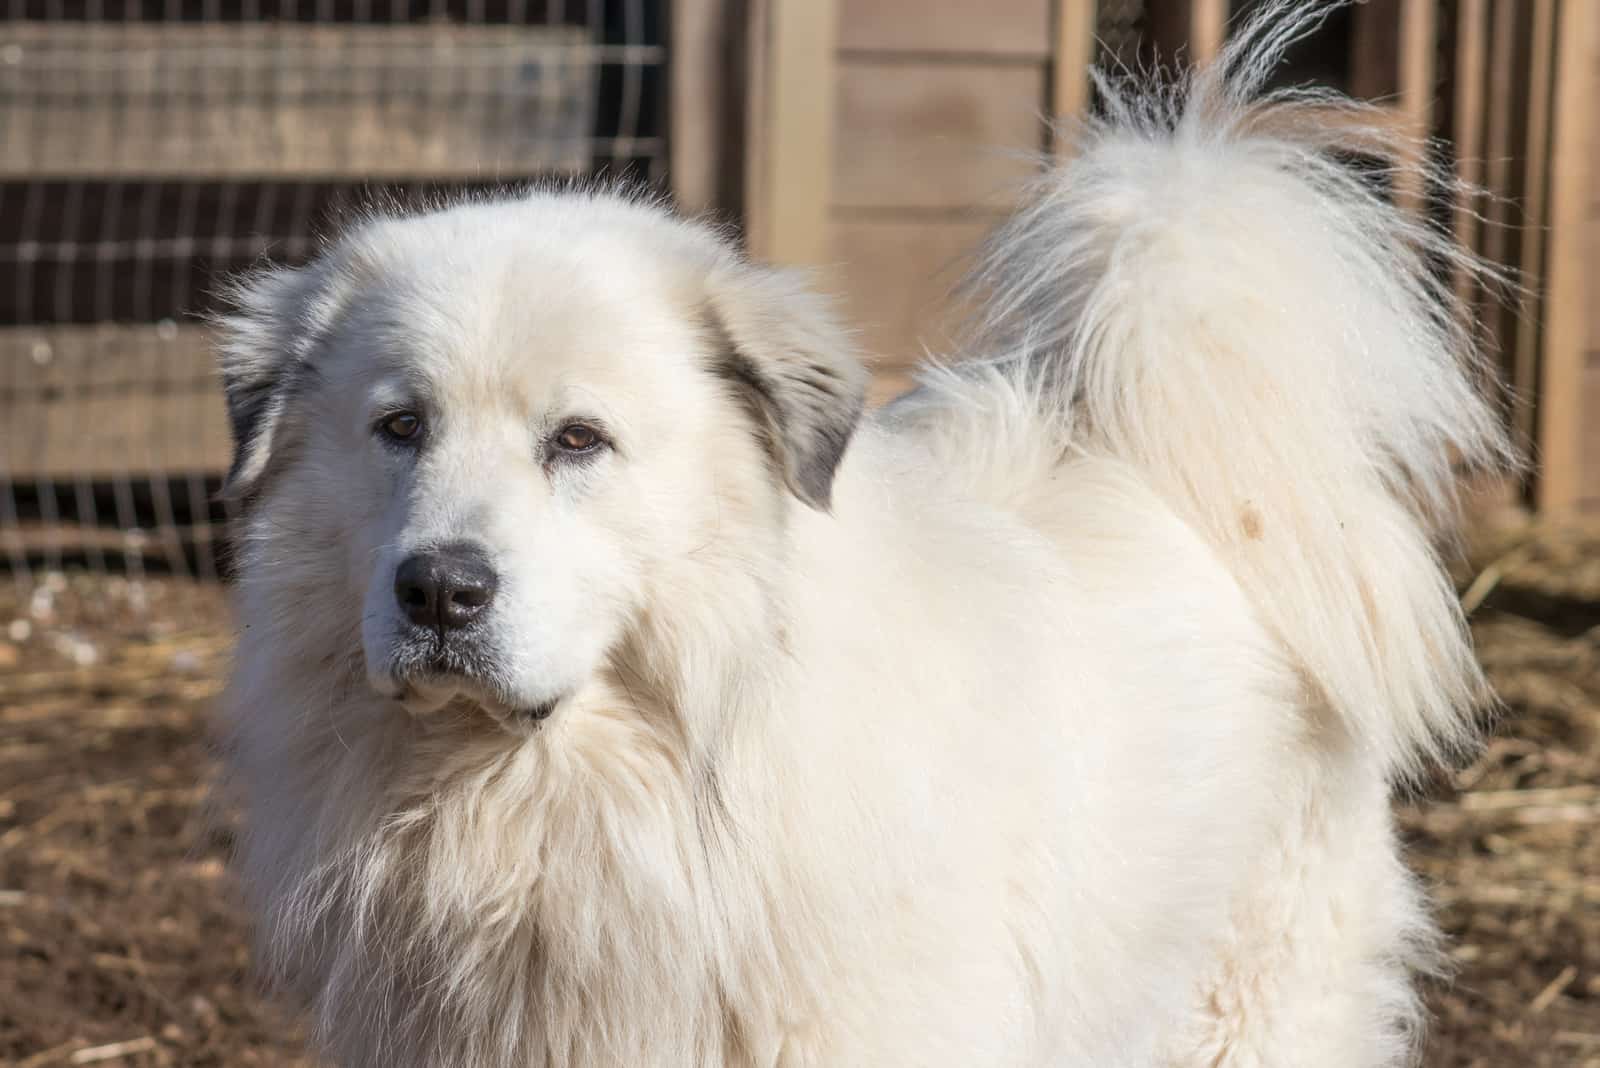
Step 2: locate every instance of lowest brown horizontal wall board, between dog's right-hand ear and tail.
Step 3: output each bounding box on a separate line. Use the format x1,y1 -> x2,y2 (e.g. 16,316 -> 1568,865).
830,216 -> 1000,368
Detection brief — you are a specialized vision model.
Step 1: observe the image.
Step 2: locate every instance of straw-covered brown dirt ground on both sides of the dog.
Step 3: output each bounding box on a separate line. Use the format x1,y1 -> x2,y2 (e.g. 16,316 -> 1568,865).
0,529 -> 1600,1068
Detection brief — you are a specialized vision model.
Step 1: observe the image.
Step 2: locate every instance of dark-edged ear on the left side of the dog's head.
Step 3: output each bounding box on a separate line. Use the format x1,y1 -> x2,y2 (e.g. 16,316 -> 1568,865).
213,259 -> 349,500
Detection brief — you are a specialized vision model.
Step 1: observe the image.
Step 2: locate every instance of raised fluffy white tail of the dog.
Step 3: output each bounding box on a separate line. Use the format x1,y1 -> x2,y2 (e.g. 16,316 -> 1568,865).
974,0 -> 1510,775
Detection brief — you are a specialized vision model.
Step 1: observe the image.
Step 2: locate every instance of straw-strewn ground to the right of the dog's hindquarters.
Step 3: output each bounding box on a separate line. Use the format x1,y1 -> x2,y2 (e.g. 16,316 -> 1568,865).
1400,528 -> 1600,1068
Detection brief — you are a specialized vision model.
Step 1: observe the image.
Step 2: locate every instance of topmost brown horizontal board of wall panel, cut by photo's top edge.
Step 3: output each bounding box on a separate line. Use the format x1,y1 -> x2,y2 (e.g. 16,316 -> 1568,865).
838,0 -> 1050,59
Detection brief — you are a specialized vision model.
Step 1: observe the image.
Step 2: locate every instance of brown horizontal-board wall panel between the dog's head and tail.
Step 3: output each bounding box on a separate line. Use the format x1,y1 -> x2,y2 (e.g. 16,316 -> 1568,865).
829,0 -> 1098,378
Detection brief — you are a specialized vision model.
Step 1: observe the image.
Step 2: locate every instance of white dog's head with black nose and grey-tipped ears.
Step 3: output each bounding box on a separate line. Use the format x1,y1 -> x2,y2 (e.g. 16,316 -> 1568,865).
222,193 -> 864,721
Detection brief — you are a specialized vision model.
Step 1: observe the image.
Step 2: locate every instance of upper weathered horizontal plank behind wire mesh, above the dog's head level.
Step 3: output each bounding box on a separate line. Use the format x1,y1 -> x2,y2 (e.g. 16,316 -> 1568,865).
0,22 -> 598,179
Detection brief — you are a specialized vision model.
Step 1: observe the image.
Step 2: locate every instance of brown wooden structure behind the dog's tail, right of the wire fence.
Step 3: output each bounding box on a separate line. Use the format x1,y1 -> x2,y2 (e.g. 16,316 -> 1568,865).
716,0 -> 1600,512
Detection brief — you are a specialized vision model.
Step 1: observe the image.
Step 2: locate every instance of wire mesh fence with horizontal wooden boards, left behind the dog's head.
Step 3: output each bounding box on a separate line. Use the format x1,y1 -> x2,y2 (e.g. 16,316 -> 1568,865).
0,0 -> 667,582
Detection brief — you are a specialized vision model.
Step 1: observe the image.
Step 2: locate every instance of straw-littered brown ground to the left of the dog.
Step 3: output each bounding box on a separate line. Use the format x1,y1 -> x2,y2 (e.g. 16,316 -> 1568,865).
0,576 -> 309,1068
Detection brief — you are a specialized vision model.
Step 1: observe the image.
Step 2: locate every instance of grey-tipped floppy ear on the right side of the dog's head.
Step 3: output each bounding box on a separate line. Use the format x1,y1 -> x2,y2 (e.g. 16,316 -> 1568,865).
706,262 -> 867,512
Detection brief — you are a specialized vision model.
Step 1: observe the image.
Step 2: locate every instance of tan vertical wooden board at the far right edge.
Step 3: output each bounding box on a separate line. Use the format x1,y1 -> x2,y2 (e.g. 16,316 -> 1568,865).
1530,0 -> 1600,513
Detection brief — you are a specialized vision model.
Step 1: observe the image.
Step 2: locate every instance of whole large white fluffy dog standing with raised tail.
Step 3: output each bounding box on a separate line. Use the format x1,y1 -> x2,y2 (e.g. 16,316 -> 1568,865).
212,5 -> 1507,1068
